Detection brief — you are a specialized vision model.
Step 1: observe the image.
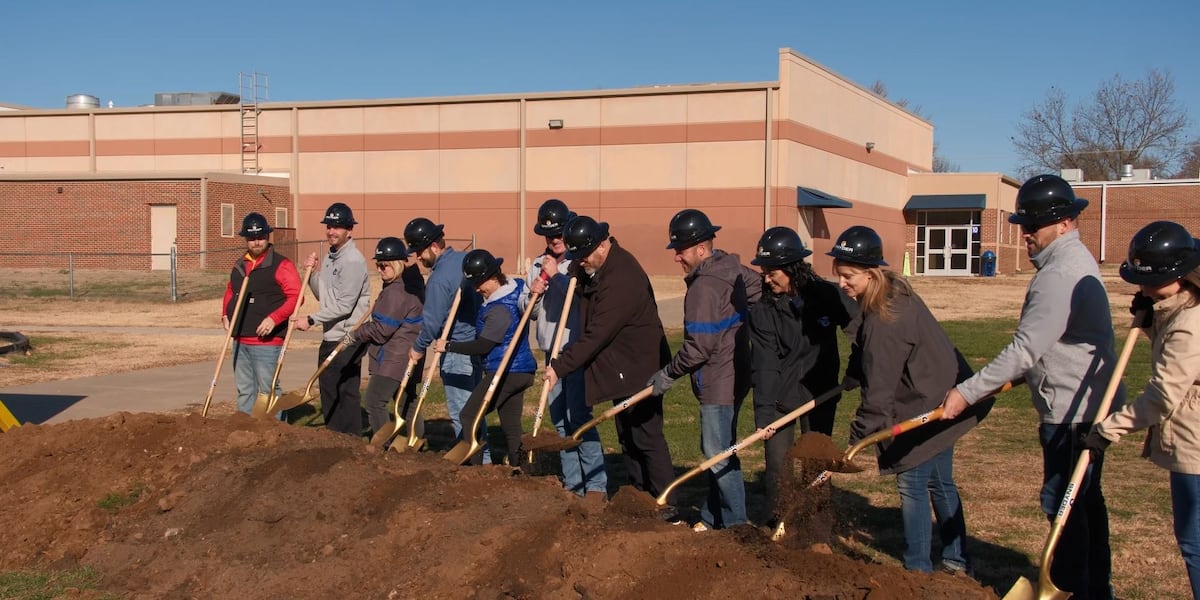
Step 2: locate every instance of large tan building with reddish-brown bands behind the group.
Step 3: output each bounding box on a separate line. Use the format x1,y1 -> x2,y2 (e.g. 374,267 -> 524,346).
0,49 -> 1019,275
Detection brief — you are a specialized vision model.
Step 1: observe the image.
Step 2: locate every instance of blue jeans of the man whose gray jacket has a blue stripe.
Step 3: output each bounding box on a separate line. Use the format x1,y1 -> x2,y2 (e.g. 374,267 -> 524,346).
700,403 -> 749,529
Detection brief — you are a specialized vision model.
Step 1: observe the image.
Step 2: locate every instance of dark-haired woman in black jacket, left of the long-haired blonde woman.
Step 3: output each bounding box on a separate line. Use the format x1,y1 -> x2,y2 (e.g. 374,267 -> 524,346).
750,227 -> 858,523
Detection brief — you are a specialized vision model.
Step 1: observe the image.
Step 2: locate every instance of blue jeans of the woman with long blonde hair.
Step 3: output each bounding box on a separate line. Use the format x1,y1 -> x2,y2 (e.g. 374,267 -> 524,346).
896,446 -> 968,572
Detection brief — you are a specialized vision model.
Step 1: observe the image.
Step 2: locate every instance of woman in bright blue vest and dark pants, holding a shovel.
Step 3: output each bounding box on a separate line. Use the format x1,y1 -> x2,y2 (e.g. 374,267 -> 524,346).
434,250 -> 538,468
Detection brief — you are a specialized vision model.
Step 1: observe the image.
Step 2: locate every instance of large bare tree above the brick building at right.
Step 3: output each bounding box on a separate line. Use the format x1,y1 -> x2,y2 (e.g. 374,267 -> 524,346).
1013,70 -> 1189,180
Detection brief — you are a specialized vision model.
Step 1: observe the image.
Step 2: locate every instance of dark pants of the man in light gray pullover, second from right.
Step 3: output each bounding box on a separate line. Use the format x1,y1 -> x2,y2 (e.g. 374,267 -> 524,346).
1038,424 -> 1112,600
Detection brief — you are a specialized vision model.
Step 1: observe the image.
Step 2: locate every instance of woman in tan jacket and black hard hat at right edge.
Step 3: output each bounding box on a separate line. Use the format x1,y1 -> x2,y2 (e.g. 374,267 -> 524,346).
1084,221 -> 1200,599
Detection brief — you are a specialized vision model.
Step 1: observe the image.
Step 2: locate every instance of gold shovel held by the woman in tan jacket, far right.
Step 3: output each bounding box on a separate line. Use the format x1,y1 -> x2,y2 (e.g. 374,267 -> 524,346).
1003,311 -> 1146,600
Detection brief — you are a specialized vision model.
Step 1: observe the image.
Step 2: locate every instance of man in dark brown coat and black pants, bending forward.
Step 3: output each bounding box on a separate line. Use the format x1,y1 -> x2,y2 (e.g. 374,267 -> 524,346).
546,216 -> 674,496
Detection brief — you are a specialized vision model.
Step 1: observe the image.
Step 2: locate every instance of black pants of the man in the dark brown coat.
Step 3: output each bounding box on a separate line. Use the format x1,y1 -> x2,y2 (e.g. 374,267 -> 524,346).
613,396 -> 674,504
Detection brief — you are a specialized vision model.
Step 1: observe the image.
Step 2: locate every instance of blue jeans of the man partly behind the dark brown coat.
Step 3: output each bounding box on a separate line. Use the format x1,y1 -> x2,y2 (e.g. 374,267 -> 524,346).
547,370 -> 608,496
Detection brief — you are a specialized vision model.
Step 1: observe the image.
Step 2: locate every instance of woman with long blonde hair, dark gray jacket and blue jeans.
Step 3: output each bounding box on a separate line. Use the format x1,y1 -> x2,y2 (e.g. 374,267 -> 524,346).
828,227 -> 991,574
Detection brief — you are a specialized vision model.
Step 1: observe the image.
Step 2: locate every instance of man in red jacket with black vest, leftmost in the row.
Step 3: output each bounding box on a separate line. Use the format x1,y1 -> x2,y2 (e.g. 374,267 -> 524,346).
221,212 -> 300,414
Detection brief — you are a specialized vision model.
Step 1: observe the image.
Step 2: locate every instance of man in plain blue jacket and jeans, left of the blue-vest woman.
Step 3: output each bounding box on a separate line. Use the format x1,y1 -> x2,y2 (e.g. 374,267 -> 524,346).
404,217 -> 491,456
